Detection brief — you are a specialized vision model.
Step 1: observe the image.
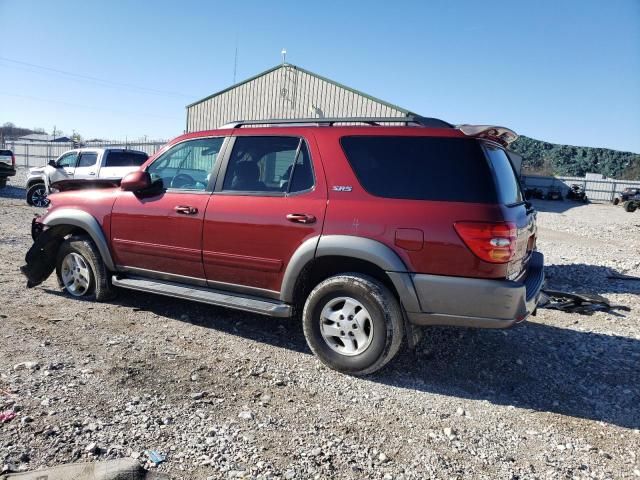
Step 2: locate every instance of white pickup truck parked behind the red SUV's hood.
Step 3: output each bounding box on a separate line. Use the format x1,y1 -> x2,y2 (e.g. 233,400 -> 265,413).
27,148 -> 149,207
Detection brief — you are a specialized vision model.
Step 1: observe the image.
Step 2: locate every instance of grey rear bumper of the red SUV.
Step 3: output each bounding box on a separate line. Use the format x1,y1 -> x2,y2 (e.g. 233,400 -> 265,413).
403,252 -> 544,328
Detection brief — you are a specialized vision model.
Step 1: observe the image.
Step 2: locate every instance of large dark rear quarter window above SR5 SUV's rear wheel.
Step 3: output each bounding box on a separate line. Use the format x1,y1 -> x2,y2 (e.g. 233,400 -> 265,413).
341,137 -> 496,203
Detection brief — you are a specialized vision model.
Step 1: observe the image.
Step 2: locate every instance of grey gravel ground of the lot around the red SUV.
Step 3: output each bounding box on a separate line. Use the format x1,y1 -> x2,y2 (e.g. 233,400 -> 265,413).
0,170 -> 640,479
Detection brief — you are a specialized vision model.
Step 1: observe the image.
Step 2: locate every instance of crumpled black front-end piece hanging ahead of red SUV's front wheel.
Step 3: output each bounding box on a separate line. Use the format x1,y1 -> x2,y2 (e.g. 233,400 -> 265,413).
20,217 -> 73,288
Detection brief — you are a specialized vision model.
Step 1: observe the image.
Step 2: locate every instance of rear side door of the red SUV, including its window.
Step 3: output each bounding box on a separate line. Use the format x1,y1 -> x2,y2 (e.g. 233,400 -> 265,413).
203,134 -> 327,297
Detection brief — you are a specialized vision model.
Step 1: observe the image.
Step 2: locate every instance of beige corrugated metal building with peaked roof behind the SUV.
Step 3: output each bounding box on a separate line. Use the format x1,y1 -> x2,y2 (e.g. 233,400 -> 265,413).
187,63 -> 415,132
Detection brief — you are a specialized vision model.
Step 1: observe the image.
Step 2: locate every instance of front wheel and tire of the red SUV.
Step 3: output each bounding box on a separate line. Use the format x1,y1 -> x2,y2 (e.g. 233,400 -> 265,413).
56,235 -> 114,302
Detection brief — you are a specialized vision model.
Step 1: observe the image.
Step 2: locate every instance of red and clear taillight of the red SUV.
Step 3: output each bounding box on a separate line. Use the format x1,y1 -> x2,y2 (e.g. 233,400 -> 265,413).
453,222 -> 518,263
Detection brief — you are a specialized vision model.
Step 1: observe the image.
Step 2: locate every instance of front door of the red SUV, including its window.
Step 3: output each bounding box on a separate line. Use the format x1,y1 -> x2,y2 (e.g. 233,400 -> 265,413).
111,137 -> 224,283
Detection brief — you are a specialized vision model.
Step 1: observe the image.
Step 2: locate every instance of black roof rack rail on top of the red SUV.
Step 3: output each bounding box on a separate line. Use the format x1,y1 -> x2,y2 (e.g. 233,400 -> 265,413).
219,115 -> 454,129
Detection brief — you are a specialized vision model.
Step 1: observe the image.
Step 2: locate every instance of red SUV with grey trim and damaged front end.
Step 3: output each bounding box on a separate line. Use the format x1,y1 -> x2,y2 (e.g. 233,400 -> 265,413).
23,117 -> 544,374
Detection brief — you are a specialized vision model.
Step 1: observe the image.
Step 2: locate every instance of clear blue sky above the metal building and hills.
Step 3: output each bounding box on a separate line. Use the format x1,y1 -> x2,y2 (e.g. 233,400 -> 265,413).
0,0 -> 640,152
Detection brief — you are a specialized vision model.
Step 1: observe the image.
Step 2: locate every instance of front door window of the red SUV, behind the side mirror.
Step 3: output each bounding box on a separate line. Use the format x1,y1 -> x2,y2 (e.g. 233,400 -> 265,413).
147,137 -> 224,191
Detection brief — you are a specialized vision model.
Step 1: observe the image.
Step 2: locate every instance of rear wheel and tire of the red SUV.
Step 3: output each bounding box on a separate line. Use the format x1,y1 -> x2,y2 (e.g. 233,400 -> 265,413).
302,273 -> 404,375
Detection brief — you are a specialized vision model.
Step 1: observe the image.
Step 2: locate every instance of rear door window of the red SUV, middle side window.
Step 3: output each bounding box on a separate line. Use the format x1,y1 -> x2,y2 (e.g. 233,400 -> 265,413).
222,136 -> 314,195
